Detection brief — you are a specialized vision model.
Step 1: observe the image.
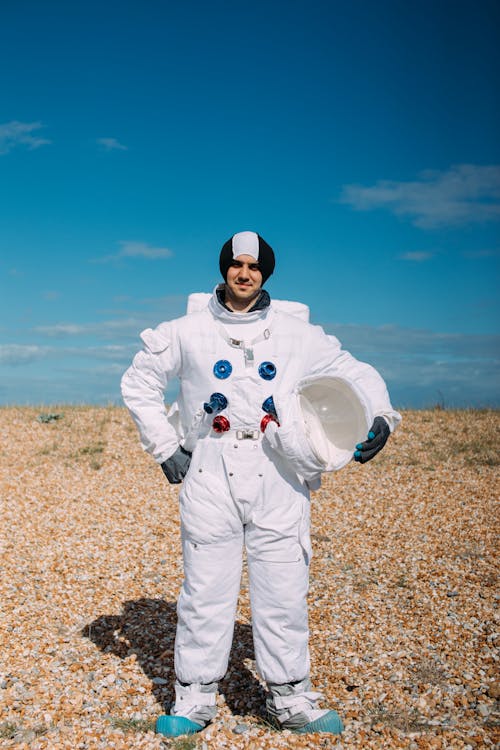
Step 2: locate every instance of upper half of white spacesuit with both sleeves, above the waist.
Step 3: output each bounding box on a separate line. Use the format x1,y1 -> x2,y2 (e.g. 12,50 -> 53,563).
122,284 -> 396,463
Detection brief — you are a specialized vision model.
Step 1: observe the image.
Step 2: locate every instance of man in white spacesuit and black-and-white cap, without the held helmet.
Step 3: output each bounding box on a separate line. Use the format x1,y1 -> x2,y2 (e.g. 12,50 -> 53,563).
122,232 -> 400,736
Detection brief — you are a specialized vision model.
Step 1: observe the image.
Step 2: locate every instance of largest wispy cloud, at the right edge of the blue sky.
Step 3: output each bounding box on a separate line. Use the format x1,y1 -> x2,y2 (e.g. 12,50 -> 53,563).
340,164 -> 500,229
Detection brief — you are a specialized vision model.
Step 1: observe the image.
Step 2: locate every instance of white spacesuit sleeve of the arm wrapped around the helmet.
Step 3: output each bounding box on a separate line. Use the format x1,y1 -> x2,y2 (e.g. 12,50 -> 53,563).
310,326 -> 401,432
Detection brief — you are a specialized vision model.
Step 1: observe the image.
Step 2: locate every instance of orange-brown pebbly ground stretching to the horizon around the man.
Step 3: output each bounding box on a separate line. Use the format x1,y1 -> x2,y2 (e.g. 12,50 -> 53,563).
0,406 -> 500,750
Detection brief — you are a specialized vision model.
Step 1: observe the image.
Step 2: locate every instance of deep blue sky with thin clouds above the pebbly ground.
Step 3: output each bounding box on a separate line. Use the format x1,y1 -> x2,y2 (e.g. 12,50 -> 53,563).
0,0 -> 500,407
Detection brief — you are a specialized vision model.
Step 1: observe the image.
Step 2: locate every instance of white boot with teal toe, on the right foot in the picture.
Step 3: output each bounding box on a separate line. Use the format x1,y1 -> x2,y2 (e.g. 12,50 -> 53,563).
266,677 -> 343,734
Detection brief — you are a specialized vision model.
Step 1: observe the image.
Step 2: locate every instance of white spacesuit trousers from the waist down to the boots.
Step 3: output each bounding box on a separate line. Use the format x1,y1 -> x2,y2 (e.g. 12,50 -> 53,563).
175,436 -> 311,684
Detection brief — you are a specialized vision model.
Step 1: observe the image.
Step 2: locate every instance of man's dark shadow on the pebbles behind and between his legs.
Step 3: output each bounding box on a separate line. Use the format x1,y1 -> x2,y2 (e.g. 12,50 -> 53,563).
81,598 -> 265,715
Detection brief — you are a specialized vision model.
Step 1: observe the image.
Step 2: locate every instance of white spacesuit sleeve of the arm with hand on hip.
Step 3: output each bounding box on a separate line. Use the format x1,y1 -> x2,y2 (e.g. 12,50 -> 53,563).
121,323 -> 180,463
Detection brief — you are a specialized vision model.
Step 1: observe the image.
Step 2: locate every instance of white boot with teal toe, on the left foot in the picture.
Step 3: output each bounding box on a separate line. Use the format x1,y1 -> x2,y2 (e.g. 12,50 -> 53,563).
156,681 -> 217,737
